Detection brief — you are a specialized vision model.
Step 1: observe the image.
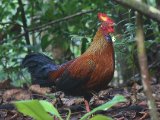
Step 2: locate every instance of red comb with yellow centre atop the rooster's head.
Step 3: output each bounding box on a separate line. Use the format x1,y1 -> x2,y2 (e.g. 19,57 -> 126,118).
98,13 -> 114,23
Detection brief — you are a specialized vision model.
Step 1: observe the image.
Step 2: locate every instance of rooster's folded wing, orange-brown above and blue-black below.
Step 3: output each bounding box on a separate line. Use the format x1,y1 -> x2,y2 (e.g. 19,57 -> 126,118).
56,56 -> 96,92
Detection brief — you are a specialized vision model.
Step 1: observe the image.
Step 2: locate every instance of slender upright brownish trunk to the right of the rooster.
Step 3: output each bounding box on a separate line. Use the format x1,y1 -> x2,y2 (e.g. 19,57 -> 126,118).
136,13 -> 159,120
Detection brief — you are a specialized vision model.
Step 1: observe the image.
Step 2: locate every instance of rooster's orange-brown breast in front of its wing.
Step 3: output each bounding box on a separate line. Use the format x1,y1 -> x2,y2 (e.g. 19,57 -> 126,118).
86,46 -> 114,91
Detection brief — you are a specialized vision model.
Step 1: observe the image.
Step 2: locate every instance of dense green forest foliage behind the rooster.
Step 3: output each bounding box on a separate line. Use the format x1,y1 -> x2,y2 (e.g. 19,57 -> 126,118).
0,0 -> 160,86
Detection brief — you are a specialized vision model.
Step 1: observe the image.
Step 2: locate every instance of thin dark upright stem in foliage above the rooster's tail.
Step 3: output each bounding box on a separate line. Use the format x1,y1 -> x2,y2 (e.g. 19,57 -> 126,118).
18,0 -> 31,51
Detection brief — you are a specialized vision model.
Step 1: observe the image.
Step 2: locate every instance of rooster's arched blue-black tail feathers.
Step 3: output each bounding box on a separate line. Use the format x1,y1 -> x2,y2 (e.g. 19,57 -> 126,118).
22,53 -> 58,86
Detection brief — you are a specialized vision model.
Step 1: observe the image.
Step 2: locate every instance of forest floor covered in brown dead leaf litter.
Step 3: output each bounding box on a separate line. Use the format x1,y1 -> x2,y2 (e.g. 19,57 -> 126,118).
0,81 -> 160,120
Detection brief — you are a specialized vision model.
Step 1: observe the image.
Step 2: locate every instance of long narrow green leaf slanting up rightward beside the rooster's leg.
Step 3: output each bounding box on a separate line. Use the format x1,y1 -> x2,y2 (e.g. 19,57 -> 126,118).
80,95 -> 126,120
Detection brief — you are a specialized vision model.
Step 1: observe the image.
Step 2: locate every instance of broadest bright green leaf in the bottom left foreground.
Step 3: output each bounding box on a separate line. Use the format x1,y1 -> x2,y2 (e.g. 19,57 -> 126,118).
14,100 -> 53,120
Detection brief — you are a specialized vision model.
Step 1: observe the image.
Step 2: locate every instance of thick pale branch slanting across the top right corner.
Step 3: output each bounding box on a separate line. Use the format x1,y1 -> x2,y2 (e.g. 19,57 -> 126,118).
114,0 -> 160,22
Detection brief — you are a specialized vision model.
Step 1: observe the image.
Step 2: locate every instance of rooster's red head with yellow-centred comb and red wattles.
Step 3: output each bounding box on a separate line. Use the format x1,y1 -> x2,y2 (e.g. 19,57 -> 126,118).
98,13 -> 114,34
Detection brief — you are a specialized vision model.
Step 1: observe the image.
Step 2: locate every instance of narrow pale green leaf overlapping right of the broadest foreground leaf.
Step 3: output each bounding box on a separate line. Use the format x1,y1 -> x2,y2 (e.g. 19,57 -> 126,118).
39,100 -> 62,120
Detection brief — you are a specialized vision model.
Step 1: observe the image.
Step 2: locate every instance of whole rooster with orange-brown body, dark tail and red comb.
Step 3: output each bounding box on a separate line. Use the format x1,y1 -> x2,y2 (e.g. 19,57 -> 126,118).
22,13 -> 114,112
